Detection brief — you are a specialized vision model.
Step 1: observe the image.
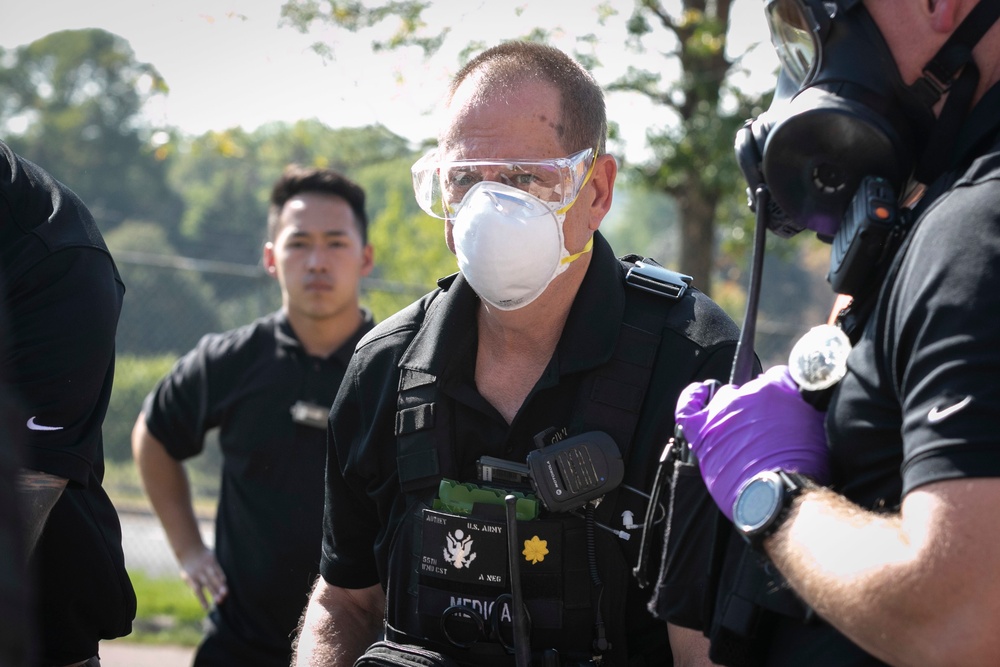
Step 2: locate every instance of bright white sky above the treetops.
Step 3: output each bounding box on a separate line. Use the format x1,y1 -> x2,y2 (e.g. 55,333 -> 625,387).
0,0 -> 774,159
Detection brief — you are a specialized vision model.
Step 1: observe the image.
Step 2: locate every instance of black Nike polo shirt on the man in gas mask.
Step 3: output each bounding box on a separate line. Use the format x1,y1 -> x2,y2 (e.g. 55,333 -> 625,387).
768,86 -> 1000,667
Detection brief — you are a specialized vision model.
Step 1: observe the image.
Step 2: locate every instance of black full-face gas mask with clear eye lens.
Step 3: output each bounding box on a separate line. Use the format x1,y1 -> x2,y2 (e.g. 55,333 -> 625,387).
735,0 -> 1000,241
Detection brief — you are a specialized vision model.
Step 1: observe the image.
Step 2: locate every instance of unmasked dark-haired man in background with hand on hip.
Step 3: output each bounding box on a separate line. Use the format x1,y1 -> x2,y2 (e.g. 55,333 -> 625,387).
132,166 -> 372,667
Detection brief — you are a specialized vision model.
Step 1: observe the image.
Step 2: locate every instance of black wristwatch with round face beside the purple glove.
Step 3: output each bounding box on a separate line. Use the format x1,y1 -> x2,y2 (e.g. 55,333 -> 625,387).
733,470 -> 815,551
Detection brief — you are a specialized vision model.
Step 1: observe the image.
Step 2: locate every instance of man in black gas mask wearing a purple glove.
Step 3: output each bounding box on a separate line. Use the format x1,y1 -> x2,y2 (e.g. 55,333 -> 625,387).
664,0 -> 1000,667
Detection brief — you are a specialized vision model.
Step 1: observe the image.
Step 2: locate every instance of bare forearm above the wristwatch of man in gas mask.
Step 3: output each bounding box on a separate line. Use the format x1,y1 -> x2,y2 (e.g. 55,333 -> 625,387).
767,490 -> 997,667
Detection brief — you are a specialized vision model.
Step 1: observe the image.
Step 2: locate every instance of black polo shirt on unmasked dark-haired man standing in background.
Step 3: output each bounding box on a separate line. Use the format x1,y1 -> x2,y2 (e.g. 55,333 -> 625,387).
144,312 -> 372,665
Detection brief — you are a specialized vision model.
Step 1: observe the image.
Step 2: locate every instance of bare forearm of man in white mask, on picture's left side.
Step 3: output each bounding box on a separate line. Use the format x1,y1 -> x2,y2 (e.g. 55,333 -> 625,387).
292,577 -> 385,667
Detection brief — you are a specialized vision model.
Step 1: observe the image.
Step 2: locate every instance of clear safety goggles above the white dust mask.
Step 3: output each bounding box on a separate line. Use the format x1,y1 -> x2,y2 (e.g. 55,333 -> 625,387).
410,148 -> 597,219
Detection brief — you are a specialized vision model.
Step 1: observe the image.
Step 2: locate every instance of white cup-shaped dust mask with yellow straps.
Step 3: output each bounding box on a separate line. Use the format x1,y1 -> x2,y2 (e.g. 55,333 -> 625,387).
452,181 -> 594,310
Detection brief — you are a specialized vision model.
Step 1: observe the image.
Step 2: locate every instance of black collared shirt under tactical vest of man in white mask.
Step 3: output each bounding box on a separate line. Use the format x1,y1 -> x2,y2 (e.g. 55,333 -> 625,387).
321,234 -> 738,664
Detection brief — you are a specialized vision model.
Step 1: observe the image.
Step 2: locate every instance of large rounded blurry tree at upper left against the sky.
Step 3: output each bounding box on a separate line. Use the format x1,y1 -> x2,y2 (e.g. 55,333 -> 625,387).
0,29 -> 180,230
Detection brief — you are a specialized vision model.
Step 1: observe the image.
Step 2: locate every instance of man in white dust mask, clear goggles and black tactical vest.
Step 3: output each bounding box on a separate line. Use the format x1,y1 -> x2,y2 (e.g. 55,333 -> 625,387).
296,42 -> 738,667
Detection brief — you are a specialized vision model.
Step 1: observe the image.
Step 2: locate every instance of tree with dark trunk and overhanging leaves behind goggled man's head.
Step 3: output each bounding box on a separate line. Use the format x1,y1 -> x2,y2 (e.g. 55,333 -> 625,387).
282,0 -> 760,298
